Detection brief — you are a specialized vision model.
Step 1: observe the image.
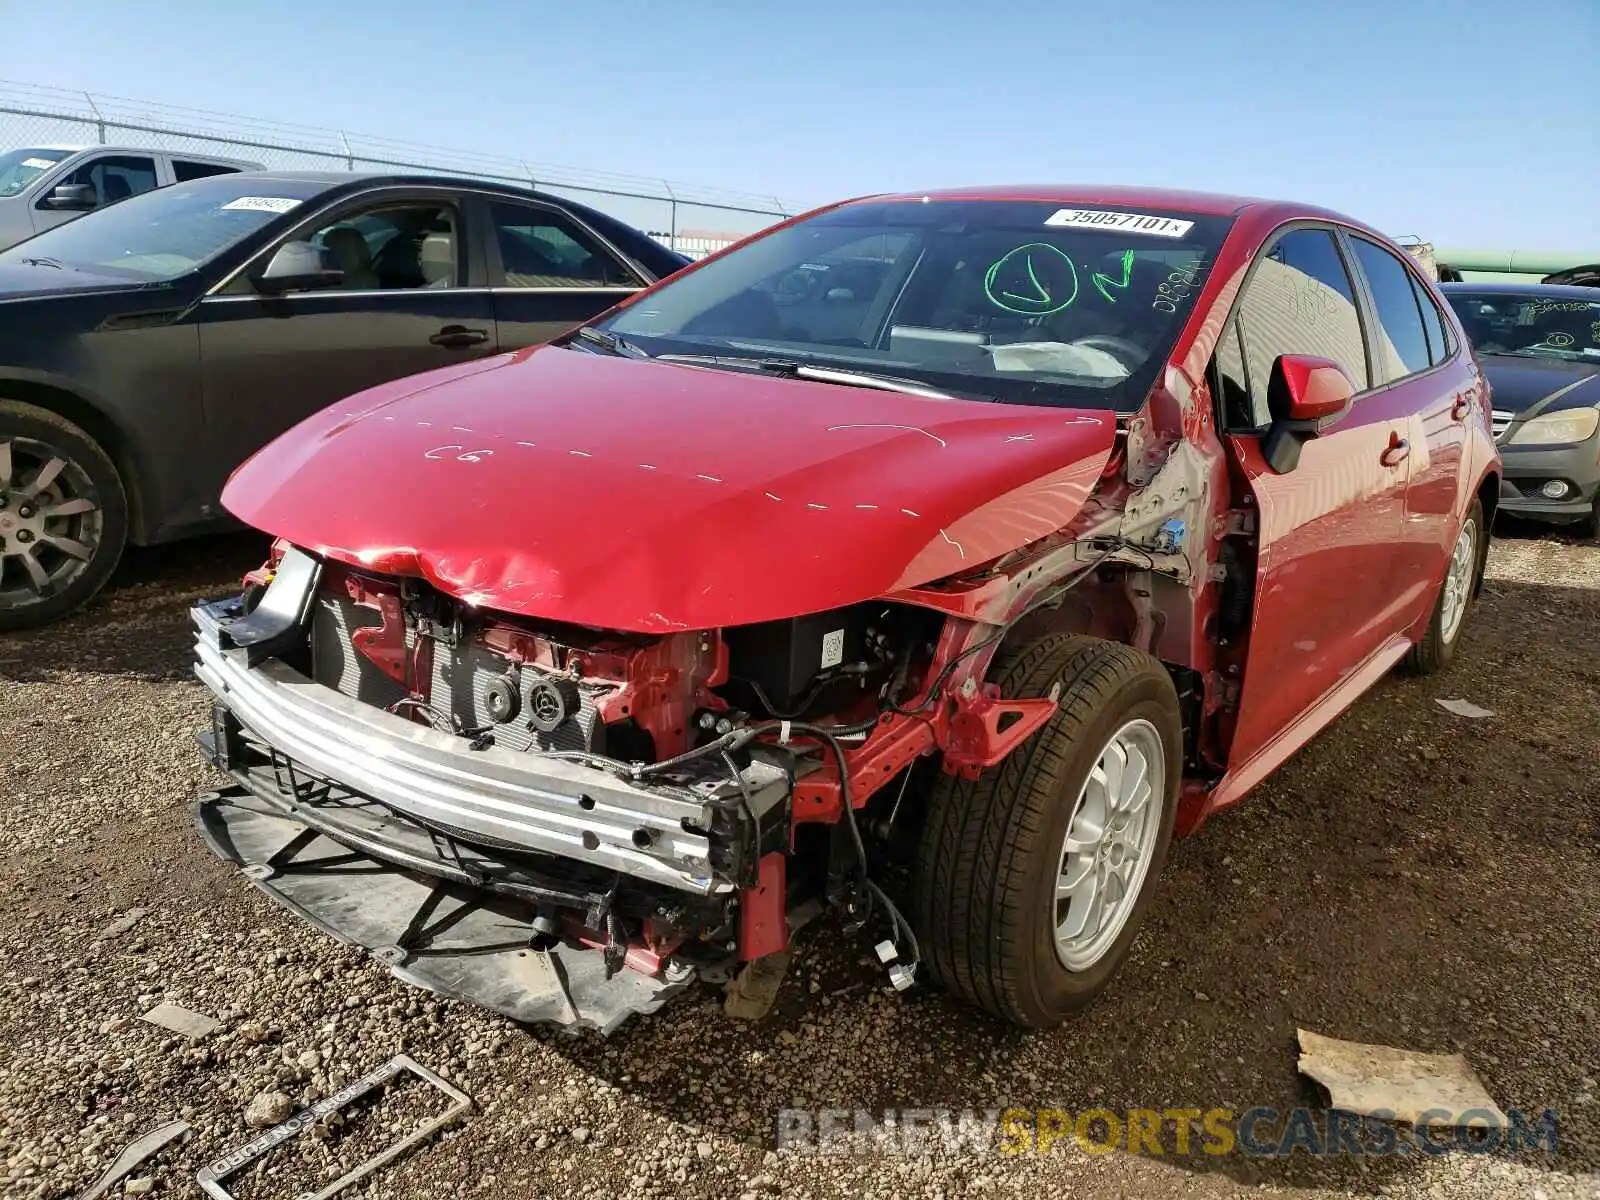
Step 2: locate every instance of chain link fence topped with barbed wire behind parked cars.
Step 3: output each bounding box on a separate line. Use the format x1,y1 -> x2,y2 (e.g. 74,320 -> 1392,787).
0,80 -> 800,258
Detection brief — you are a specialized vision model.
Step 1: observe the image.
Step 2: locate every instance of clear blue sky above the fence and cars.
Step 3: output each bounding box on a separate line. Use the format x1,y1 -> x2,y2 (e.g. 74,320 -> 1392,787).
0,0 -> 1600,250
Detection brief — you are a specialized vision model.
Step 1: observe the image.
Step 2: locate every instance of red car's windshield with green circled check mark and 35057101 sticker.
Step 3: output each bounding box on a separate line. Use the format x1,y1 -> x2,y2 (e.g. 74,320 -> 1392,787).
602,200 -> 1230,411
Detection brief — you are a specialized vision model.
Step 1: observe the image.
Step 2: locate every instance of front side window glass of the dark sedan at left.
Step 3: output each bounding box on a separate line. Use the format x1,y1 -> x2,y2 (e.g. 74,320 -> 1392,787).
309,203 -> 461,291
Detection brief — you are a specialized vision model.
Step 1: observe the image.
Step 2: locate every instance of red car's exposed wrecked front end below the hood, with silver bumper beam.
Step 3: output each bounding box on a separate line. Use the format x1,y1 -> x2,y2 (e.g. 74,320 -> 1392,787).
192,521 -> 1132,1032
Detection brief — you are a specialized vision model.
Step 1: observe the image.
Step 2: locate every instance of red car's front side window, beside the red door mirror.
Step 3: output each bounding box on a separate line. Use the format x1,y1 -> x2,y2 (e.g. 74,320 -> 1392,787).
1218,229 -> 1366,429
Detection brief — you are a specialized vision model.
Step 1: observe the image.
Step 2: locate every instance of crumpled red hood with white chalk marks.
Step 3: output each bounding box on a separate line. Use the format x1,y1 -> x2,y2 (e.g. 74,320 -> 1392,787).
222,347 -> 1117,632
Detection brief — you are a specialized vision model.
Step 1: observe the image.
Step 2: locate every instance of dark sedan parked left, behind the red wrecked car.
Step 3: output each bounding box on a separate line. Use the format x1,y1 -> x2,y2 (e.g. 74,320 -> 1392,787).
0,173 -> 688,630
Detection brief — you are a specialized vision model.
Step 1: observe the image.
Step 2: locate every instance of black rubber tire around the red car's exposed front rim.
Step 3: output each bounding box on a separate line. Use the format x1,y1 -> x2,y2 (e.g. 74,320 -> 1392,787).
912,634 -> 1182,1029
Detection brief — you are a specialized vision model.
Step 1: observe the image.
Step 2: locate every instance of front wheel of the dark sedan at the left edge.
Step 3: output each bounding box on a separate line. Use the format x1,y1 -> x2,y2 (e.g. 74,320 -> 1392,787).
0,400 -> 128,630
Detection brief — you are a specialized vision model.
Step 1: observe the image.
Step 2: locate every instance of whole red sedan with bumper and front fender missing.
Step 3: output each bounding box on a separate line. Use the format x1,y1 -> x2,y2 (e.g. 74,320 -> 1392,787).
194,187 -> 1499,1029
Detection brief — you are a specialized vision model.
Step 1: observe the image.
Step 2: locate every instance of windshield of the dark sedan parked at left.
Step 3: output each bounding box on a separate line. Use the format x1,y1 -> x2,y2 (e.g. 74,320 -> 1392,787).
0,174 -> 328,283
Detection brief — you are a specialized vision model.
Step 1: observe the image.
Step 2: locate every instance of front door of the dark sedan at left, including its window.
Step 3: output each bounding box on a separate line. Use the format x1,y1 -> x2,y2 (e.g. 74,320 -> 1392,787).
200,190 -> 498,494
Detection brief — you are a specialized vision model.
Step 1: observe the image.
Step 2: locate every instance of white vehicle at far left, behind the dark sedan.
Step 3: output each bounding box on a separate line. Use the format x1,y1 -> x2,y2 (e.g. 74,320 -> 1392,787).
0,146 -> 261,250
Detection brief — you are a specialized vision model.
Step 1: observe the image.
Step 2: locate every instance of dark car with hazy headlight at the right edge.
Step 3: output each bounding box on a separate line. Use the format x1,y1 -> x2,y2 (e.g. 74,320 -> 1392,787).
1442,283 -> 1600,538
